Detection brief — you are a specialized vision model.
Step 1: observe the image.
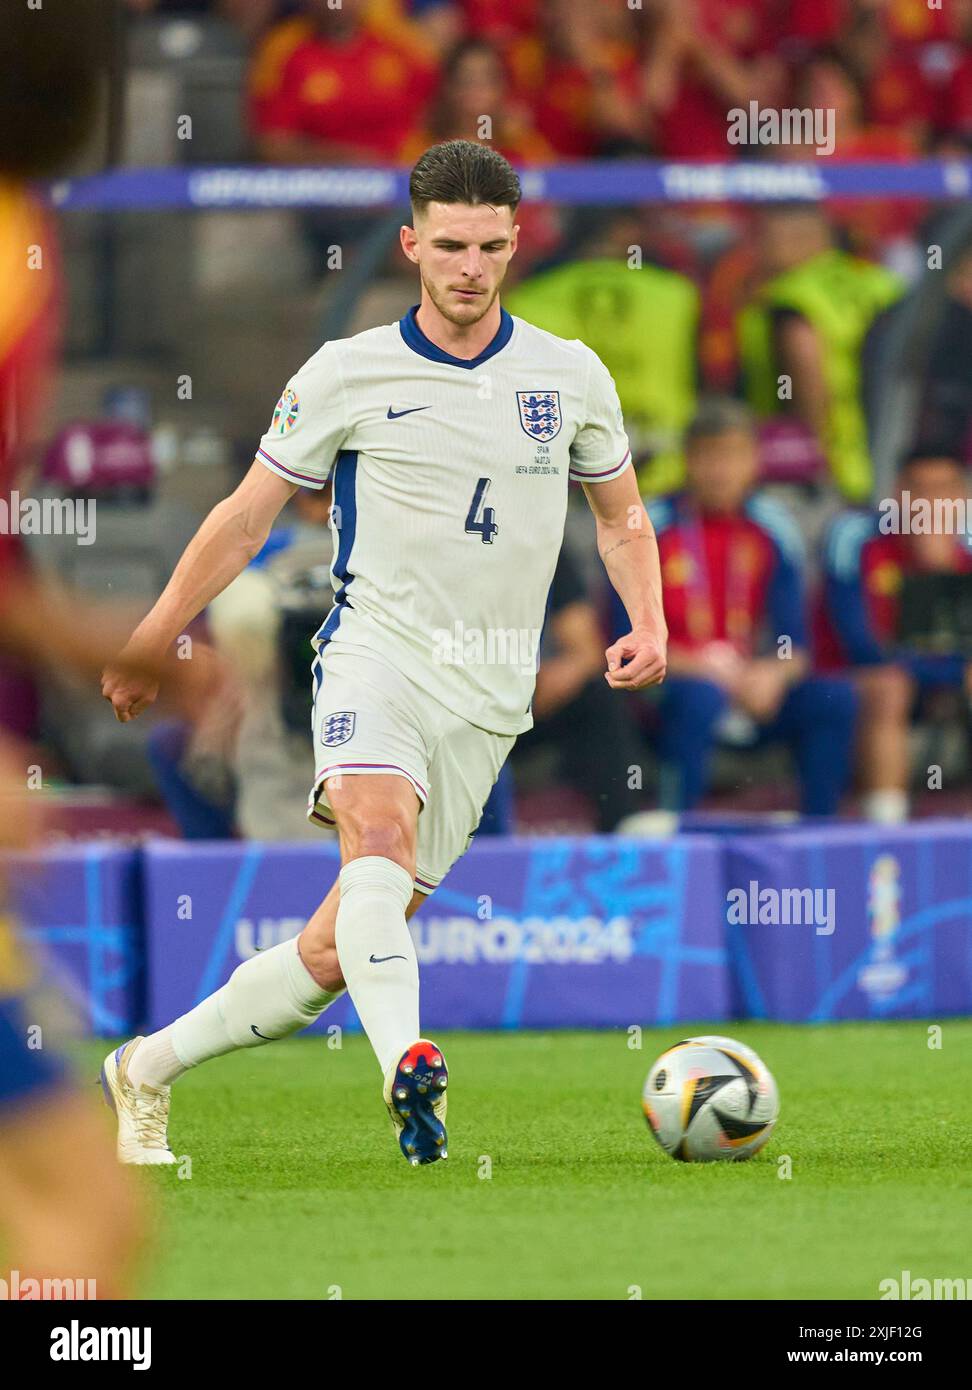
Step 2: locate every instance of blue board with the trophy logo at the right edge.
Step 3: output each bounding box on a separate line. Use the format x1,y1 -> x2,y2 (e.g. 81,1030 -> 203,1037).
724,821 -> 972,1023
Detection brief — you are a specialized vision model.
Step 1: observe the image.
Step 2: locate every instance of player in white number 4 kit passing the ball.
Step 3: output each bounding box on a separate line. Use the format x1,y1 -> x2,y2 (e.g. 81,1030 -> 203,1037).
104,140 -> 666,1163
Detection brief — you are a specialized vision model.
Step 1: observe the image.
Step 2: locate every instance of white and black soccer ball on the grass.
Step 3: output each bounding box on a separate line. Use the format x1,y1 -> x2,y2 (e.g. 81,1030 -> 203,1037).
641,1036 -> 780,1163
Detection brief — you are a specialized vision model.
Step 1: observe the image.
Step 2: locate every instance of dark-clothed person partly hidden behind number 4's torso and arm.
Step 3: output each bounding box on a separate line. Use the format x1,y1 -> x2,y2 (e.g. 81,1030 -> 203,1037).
513,548 -> 645,831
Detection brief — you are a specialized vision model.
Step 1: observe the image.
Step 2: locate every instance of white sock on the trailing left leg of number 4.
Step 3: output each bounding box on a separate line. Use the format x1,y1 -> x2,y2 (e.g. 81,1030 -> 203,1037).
128,937 -> 343,1086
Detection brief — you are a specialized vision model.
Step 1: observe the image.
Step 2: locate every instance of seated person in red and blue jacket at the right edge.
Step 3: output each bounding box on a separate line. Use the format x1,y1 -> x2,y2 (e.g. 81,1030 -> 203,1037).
818,452 -> 972,823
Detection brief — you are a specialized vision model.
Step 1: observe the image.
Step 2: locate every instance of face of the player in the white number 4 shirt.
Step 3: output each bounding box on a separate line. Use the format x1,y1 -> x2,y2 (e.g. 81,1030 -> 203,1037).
402,203 -> 519,327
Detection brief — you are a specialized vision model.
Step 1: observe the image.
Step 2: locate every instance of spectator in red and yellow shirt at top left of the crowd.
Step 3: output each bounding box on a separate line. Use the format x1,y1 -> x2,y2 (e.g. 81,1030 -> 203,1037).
250,0 -> 437,164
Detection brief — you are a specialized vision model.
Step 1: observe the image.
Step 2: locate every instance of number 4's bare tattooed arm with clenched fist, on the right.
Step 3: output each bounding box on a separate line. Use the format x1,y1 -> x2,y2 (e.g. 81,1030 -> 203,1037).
584,467 -> 669,691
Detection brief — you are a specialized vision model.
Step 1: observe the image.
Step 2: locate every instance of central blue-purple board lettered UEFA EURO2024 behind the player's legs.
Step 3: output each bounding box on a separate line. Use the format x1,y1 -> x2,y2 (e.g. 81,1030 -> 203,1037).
145,835 -> 729,1030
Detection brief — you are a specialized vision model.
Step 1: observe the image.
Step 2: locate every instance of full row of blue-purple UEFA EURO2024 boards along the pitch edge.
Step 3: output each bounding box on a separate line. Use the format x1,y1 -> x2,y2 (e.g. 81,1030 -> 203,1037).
8,820 -> 972,1036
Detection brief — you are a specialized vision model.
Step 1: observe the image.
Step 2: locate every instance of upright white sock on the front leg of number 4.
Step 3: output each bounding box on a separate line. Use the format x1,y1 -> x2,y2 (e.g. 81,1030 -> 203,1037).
335,855 -> 421,1076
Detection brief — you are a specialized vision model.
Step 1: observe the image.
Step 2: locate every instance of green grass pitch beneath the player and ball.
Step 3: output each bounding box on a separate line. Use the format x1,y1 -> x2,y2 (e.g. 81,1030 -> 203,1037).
82,1020 -> 972,1300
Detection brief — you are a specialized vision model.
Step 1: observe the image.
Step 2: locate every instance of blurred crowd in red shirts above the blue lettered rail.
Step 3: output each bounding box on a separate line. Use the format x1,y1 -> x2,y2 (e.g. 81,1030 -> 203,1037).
127,0 -> 972,164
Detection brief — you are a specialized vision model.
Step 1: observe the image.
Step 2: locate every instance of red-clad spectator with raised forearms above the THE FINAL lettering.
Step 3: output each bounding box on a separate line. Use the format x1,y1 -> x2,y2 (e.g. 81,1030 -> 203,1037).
642,0 -> 784,160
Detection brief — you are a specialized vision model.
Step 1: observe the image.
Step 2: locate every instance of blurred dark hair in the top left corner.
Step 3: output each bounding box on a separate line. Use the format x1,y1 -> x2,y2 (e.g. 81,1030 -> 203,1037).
0,0 -> 113,178
